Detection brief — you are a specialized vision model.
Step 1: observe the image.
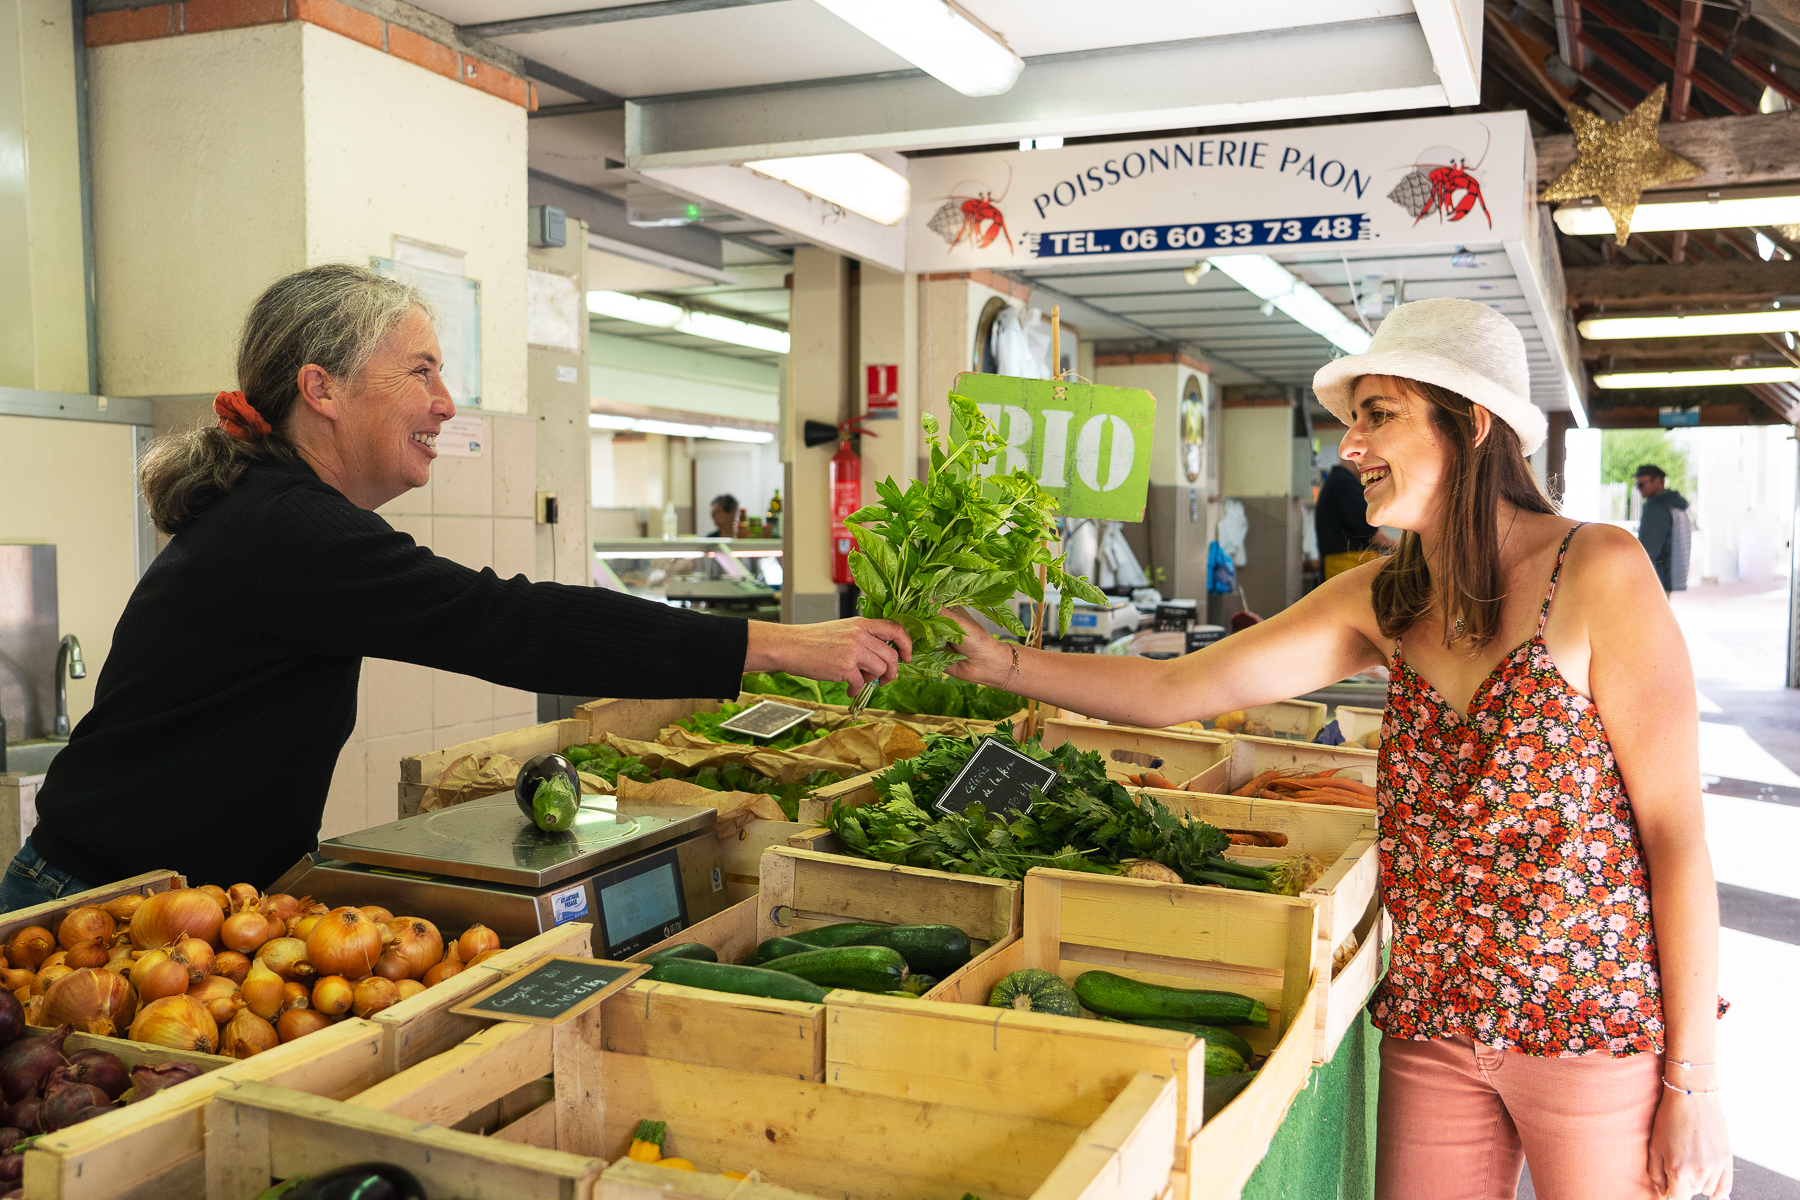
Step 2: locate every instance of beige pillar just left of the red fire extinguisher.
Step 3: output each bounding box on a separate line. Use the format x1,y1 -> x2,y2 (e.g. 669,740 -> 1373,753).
781,246 -> 851,624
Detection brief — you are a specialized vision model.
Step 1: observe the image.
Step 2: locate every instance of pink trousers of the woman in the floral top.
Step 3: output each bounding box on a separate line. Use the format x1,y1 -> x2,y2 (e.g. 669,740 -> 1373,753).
1375,1036 -> 1663,1200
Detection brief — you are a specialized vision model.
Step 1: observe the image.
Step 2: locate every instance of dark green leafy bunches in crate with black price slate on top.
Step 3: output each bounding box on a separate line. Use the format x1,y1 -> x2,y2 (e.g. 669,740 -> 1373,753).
824,729 -> 1300,896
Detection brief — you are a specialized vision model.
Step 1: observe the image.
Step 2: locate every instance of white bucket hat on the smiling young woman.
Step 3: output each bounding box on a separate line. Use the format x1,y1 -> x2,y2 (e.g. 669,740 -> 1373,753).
1312,297 -> 1550,453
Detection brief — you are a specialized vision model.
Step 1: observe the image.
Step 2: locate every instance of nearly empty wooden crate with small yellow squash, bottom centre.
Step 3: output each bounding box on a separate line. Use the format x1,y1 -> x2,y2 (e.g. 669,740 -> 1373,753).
598,1054 -> 1175,1200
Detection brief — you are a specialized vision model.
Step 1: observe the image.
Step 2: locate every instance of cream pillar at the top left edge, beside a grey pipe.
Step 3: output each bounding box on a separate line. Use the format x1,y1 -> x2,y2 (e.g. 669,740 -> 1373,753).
0,0 -> 92,392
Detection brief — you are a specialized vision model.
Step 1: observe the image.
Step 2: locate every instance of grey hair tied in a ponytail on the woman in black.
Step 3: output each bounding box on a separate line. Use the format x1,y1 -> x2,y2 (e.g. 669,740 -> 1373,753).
139,271 -> 430,536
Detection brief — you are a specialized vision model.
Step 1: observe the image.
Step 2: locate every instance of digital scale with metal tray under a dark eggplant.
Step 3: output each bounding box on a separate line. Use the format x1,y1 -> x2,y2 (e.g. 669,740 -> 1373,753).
270,793 -> 725,959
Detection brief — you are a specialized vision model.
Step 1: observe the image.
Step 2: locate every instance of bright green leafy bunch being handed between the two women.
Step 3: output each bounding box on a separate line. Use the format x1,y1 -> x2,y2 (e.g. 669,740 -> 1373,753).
844,392 -> 1105,678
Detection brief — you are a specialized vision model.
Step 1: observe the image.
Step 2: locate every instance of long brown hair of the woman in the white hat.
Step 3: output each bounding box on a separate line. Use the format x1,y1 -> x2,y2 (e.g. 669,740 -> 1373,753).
1370,380 -> 1557,655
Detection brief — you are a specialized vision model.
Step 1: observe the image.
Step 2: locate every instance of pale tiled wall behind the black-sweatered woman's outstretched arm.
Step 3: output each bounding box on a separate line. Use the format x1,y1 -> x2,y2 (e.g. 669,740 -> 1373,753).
319,412 -> 538,838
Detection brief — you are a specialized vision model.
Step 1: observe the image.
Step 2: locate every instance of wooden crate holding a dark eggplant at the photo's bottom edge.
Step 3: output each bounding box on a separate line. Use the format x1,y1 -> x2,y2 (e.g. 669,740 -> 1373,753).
201,1086 -> 607,1200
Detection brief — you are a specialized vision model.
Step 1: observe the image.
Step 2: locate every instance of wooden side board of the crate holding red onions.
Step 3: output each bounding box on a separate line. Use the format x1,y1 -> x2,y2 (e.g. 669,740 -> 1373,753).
25,1018 -> 382,1200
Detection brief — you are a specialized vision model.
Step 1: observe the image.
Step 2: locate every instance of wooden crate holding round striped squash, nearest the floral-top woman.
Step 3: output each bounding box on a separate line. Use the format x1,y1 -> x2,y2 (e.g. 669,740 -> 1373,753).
918,869 -> 1328,1200
